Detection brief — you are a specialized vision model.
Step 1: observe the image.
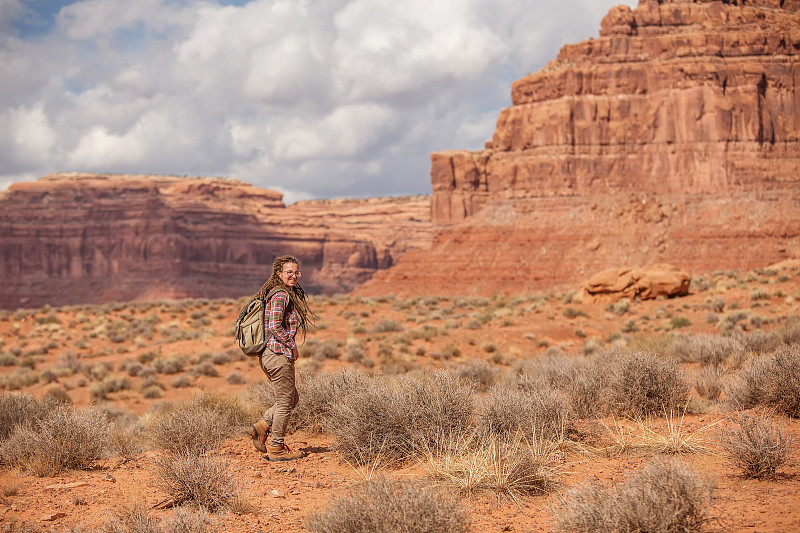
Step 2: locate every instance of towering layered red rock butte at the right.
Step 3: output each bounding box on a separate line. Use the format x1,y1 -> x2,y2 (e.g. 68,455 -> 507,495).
357,0 -> 800,295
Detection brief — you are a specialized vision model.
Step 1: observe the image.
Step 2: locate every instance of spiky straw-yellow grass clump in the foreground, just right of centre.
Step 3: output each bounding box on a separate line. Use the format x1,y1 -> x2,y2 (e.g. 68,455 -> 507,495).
422,430 -> 563,503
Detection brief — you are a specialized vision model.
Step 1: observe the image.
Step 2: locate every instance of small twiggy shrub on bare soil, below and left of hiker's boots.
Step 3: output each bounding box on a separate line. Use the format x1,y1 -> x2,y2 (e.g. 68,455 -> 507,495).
153,451 -> 248,512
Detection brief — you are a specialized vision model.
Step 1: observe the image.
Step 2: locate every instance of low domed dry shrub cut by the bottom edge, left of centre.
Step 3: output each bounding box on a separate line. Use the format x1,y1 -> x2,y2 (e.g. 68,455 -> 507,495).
305,478 -> 469,533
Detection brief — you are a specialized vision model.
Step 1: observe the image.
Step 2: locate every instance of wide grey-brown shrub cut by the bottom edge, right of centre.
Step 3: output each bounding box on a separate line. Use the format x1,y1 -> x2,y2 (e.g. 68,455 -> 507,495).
555,460 -> 713,533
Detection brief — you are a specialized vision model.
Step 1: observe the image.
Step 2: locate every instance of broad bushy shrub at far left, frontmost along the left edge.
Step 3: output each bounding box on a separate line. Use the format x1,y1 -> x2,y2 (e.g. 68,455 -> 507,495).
0,406 -> 111,477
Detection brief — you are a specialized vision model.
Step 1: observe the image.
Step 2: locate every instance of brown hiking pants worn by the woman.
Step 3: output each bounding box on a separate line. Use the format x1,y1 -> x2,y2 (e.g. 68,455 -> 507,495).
261,349 -> 300,446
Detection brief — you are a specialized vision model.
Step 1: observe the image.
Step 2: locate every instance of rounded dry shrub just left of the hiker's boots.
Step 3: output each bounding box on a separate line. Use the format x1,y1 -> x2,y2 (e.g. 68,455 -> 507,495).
145,398 -> 232,453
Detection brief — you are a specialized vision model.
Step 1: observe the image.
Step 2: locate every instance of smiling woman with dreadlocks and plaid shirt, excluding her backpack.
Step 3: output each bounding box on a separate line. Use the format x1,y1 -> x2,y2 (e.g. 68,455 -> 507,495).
249,255 -> 316,461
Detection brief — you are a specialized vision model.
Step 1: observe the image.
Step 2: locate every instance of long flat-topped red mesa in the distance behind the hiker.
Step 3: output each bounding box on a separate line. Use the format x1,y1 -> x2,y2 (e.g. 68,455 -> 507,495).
0,173 -> 431,309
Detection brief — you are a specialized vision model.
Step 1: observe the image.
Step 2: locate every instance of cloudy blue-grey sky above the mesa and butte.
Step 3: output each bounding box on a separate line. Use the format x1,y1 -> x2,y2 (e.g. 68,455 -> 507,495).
0,0 -> 637,203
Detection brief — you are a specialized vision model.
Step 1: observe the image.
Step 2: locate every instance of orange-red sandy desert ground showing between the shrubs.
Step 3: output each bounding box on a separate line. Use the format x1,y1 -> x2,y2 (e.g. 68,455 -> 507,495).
0,264 -> 800,532
